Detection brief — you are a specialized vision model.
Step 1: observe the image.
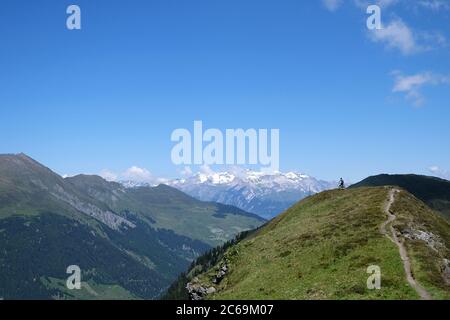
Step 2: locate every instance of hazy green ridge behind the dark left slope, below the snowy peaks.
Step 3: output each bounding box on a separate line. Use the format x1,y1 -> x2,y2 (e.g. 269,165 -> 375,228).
65,175 -> 265,247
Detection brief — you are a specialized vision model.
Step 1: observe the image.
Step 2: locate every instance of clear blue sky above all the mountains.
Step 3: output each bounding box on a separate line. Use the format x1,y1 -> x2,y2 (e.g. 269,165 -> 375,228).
0,0 -> 450,181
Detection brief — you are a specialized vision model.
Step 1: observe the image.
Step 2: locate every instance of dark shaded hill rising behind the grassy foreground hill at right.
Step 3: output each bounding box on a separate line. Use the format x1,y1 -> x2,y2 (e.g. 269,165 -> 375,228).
350,174 -> 450,219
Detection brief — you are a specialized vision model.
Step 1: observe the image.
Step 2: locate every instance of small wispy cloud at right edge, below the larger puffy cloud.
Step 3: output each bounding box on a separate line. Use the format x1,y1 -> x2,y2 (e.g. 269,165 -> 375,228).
392,71 -> 450,107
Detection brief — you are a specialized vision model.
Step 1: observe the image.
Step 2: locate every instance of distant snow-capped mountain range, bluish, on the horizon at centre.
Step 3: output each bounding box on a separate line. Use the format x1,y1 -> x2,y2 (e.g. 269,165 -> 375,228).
118,170 -> 337,219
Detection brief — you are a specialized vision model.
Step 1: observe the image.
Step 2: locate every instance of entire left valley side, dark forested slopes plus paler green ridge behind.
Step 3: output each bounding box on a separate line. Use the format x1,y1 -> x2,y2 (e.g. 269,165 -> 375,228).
0,154 -> 264,299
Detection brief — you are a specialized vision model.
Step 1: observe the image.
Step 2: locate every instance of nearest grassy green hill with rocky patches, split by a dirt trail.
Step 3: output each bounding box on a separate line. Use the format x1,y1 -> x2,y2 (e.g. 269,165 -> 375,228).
166,187 -> 450,299
